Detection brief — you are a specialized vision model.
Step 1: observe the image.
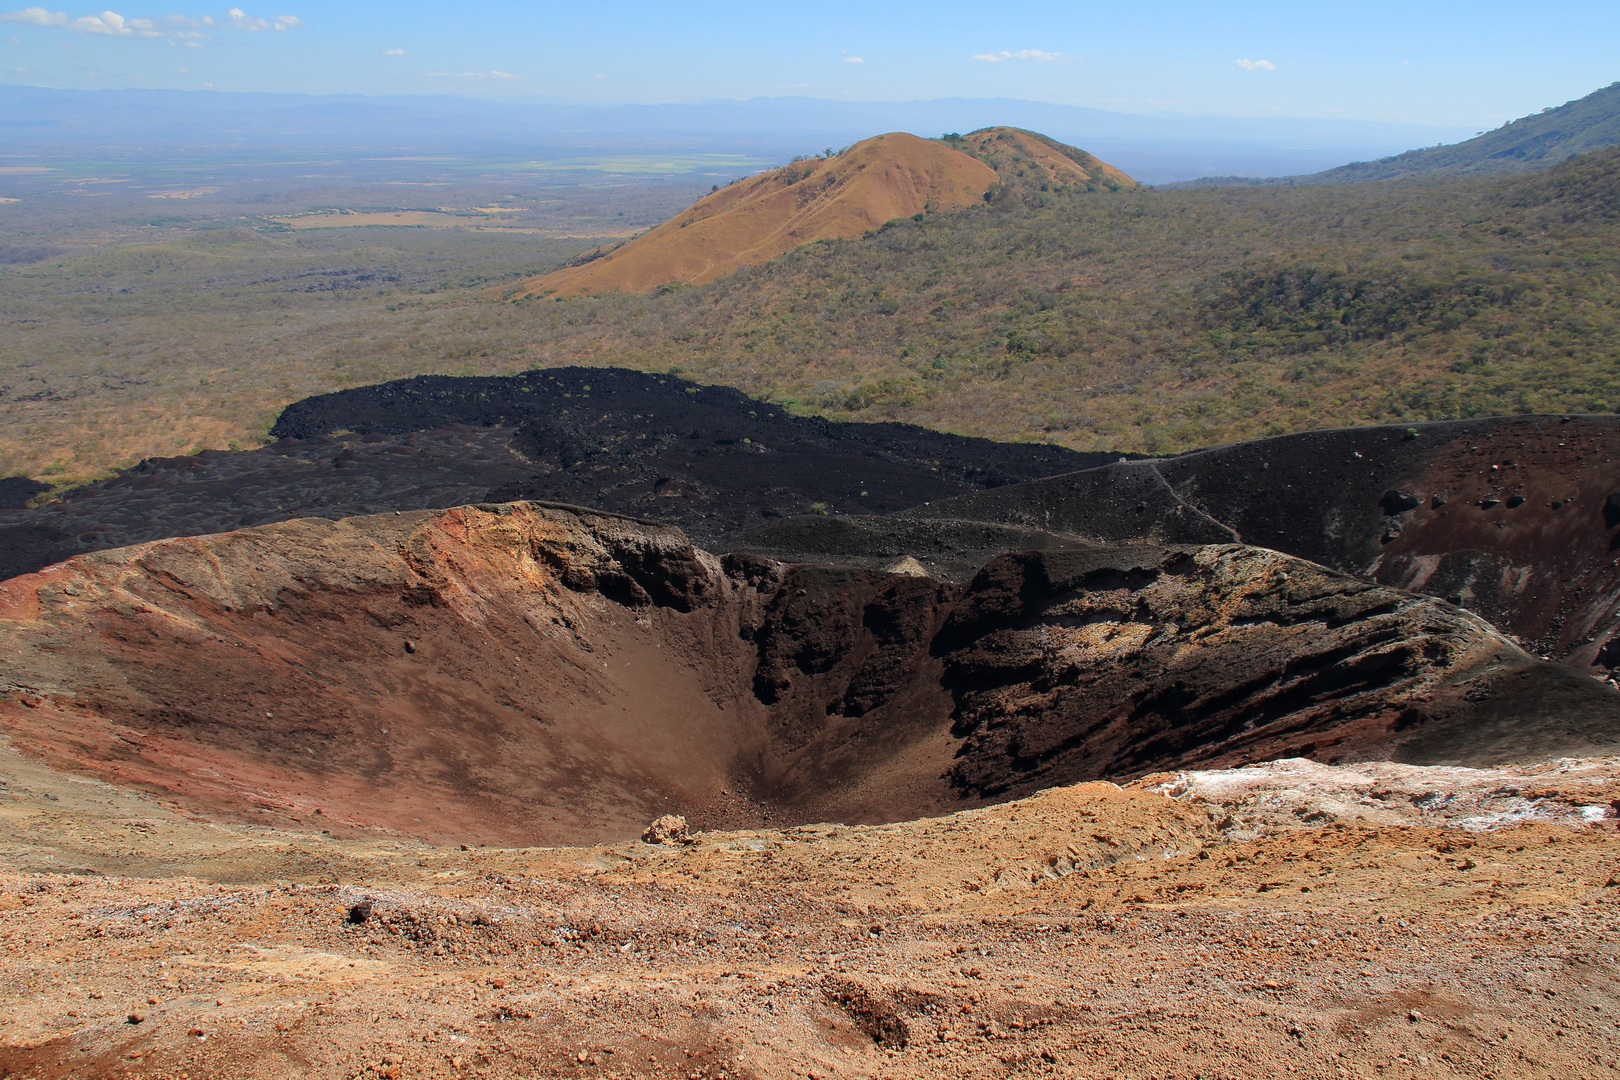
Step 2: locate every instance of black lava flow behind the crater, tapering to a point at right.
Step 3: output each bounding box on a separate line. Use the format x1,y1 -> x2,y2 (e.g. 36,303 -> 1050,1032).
0,368 -> 1113,580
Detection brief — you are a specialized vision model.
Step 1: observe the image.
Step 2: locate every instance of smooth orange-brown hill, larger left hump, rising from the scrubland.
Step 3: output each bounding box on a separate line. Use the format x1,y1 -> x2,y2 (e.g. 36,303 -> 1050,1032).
520,131 -> 996,295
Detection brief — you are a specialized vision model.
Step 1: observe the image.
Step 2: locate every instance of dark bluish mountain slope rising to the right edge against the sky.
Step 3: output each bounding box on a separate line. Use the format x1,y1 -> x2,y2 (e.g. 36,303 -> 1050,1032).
1189,83 -> 1620,186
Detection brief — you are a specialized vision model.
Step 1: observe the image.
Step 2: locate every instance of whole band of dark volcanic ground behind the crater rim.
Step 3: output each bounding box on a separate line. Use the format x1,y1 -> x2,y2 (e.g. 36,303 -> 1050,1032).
9,368 -> 1620,674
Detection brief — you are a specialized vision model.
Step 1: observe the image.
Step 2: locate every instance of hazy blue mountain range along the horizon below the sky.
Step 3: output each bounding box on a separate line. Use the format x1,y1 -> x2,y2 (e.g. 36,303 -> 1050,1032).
0,84 -> 1471,183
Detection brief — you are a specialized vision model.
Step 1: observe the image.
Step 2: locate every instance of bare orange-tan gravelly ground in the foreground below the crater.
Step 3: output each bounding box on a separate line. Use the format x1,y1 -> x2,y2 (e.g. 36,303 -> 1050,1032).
0,748 -> 1620,1078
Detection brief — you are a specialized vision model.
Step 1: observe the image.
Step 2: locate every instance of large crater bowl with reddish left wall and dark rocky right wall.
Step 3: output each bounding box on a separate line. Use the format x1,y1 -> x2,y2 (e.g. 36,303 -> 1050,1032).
0,504 -> 1620,844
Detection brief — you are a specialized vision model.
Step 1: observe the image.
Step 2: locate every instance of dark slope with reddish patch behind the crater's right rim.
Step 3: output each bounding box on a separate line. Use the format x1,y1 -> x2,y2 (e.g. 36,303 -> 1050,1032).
894,416 -> 1620,665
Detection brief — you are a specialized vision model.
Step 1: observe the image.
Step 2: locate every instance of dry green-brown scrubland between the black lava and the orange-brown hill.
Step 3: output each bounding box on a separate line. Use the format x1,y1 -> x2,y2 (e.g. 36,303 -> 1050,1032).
0,141 -> 1620,483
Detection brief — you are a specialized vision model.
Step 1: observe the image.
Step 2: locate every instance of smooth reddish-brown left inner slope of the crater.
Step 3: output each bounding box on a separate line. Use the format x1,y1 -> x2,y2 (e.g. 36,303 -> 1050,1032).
0,512 -> 784,842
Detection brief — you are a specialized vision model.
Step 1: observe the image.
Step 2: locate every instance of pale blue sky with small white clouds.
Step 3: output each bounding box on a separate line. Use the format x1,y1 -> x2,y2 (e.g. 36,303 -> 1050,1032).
0,0 -> 1620,128
